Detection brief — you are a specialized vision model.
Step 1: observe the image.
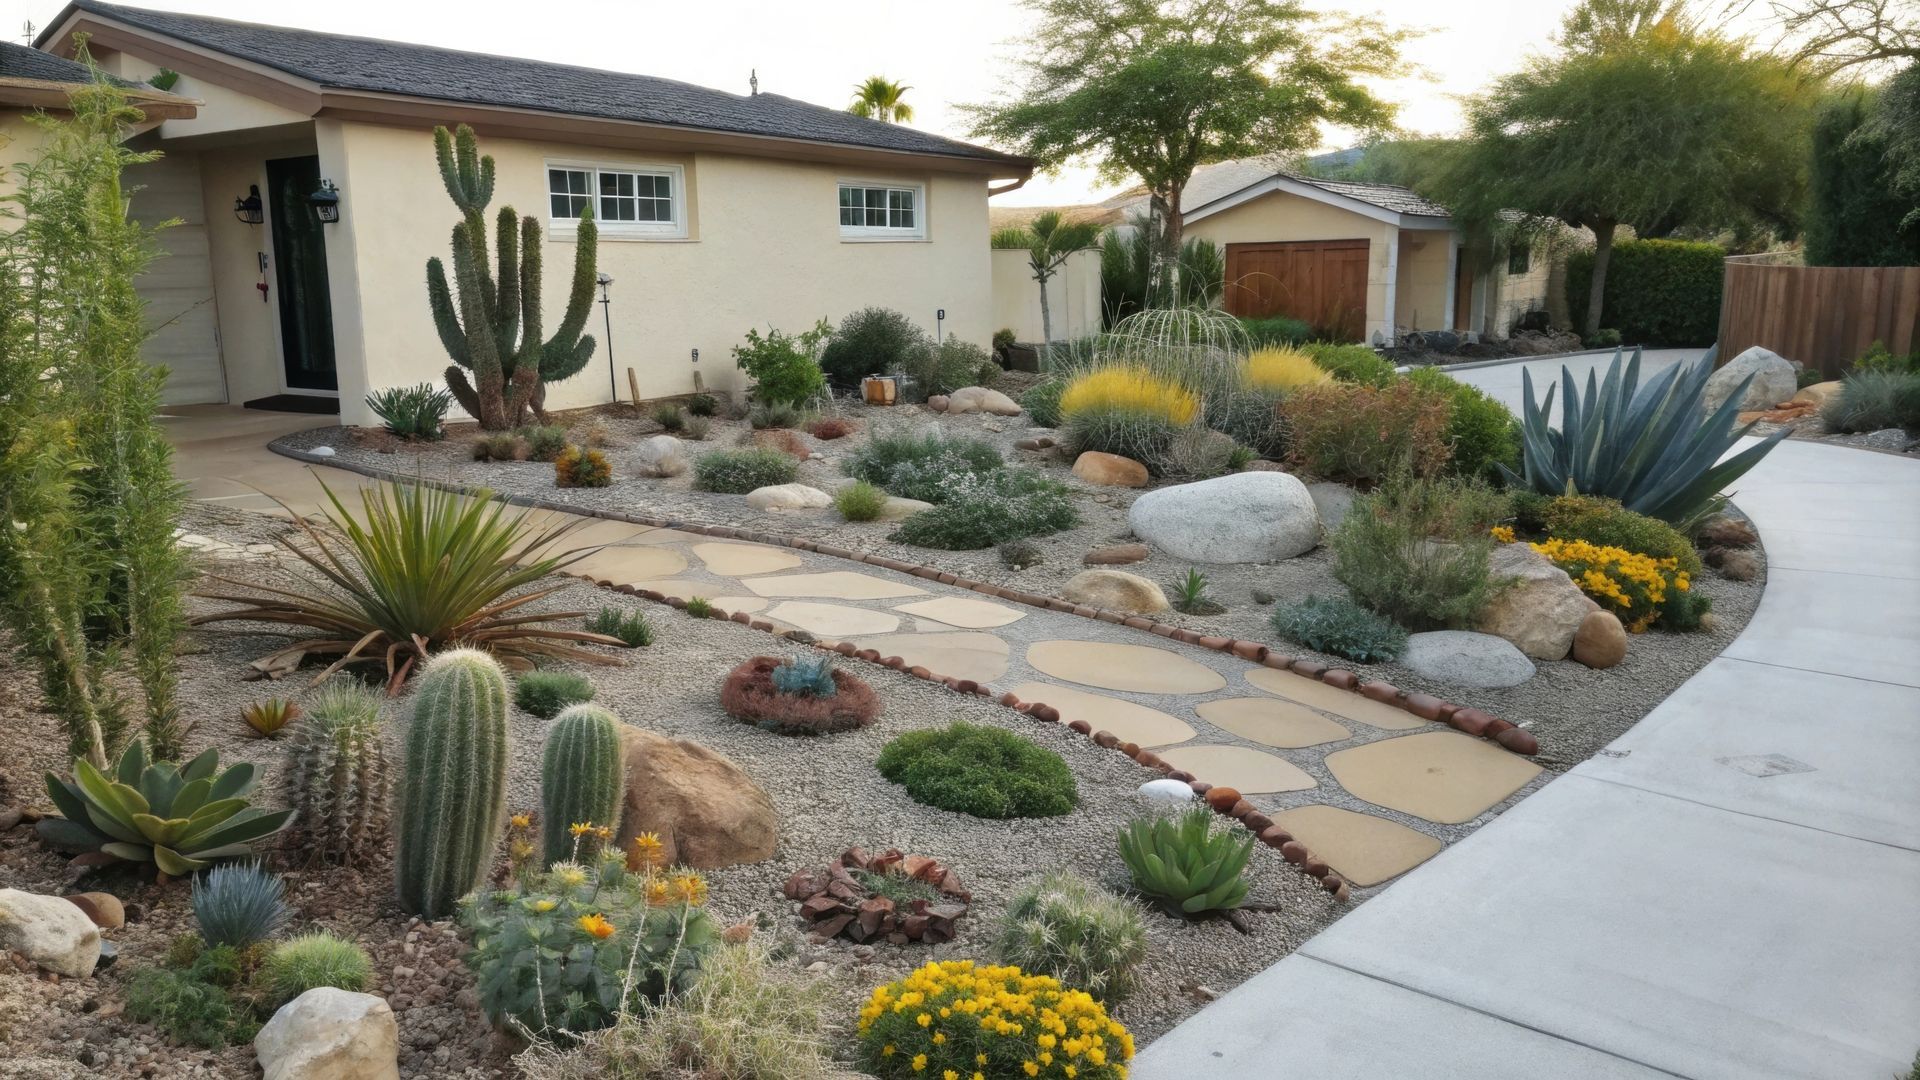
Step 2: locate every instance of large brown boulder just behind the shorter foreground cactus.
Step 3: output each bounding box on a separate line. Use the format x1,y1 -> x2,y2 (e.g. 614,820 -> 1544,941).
620,726 -> 776,871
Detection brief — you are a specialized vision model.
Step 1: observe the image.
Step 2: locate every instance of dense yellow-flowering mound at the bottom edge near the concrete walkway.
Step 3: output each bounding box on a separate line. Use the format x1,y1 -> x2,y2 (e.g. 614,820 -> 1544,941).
860,961 -> 1133,1080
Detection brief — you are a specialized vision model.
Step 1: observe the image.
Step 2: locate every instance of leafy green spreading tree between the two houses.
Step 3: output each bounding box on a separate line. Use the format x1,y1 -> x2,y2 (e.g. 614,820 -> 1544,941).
966,0 -> 1405,252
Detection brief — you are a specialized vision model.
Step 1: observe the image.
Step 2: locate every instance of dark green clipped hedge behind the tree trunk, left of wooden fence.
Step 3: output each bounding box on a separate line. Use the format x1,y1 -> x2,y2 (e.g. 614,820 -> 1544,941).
1567,240 -> 1726,346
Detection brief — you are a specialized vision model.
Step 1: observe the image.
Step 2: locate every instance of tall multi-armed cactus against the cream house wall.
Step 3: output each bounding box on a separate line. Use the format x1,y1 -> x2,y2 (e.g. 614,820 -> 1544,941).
426,123 -> 599,430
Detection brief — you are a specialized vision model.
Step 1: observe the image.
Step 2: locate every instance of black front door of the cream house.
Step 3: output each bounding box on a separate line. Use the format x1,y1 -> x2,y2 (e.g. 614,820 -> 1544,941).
267,158 -> 340,390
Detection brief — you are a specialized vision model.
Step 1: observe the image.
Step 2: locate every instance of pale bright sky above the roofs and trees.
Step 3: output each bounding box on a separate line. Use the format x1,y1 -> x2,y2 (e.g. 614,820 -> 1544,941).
0,0 -> 1766,206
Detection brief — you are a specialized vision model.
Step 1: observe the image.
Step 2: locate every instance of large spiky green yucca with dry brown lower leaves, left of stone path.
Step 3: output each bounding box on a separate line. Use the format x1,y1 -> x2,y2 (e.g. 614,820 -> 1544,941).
194,482 -> 622,696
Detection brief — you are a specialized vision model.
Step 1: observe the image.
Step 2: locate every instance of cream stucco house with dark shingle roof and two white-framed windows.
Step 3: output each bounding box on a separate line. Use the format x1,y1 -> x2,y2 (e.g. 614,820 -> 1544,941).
18,0 -> 1031,425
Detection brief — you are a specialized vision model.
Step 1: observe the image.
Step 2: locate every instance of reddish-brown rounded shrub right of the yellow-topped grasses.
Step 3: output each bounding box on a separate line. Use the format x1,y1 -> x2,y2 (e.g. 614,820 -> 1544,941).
1281,380 -> 1448,484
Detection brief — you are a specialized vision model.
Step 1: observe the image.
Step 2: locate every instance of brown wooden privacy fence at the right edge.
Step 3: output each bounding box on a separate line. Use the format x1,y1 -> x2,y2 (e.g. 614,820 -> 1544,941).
1720,256 -> 1920,379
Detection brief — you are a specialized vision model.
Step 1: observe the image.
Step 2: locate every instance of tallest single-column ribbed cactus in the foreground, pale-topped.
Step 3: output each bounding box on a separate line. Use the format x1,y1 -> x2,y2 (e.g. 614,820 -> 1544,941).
394,650 -> 507,919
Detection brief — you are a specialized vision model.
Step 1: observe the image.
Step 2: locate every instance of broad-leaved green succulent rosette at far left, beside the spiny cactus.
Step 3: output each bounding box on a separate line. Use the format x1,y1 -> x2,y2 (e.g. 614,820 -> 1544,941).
36,738 -> 294,878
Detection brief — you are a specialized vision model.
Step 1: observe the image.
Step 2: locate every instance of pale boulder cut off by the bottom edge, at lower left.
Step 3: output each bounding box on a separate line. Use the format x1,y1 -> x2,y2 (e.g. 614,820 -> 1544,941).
253,986 -> 399,1080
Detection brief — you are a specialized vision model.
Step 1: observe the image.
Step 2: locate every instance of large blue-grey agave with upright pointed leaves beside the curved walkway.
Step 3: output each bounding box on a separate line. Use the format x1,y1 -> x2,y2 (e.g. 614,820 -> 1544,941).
1500,346 -> 1788,530
